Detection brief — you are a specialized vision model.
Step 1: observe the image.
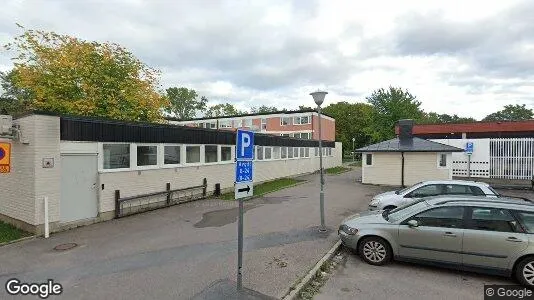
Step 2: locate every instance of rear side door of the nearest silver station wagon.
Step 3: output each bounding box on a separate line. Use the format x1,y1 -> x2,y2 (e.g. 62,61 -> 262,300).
462,207 -> 528,270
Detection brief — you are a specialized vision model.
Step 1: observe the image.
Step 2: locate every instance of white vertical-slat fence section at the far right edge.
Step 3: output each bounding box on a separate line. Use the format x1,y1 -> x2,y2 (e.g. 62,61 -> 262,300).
490,138 -> 534,179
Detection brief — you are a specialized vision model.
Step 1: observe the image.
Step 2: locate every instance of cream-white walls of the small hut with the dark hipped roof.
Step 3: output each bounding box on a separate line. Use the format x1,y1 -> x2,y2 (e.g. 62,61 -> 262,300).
362,152 -> 452,186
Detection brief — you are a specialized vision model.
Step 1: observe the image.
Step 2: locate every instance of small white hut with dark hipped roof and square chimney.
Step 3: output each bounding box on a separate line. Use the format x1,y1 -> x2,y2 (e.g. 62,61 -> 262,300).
356,120 -> 463,186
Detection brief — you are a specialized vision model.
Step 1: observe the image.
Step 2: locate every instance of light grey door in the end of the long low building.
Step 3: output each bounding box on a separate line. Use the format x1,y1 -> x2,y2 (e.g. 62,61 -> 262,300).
60,154 -> 98,222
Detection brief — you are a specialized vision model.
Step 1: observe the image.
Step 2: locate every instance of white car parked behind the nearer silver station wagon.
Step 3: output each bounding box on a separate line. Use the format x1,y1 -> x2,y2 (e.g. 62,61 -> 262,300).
369,180 -> 499,210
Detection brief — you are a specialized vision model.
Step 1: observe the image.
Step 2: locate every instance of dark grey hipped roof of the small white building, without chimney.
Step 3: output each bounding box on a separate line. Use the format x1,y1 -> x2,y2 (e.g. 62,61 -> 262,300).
356,137 -> 464,152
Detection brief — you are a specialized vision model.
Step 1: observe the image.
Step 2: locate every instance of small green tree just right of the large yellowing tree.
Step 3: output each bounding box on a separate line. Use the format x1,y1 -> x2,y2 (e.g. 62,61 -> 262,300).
165,87 -> 208,120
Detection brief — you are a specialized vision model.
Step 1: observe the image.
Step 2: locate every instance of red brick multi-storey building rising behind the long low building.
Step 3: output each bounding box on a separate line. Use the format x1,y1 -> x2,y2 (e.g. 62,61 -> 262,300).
169,110 -> 336,141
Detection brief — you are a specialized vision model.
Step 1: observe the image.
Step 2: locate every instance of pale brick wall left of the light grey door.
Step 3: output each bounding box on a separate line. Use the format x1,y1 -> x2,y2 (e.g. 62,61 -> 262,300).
0,115 -> 61,230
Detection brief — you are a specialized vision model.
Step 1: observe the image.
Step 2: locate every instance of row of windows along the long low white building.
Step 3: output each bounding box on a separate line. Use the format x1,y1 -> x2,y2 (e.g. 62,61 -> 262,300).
102,144 -> 332,170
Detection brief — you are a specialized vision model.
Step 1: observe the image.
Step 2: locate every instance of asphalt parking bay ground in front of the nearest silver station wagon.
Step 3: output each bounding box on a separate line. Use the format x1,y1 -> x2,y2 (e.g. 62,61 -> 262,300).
314,249 -> 516,300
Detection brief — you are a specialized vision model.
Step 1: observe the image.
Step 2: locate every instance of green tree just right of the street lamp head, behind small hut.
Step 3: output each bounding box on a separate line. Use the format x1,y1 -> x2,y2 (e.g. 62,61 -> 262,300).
323,102 -> 373,151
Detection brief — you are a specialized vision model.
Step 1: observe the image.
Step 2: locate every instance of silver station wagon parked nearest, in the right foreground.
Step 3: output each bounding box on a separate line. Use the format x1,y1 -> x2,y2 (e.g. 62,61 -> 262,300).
338,196 -> 534,286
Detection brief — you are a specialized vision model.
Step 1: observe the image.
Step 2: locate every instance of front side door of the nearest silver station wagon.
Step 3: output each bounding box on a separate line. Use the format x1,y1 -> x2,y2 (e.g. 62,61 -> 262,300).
398,206 -> 464,264
